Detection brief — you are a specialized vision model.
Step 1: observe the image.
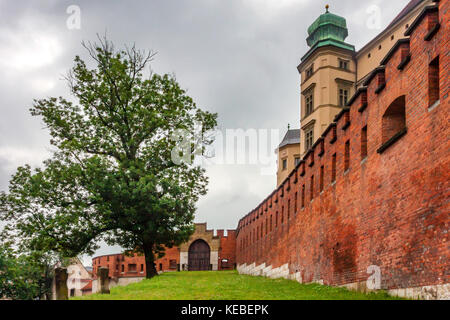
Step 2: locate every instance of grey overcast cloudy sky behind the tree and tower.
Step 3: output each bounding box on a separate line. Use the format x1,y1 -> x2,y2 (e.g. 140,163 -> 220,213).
0,0 -> 414,261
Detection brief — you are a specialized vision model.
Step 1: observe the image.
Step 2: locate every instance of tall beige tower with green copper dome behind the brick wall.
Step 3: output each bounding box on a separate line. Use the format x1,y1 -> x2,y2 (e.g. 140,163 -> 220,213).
297,5 -> 356,155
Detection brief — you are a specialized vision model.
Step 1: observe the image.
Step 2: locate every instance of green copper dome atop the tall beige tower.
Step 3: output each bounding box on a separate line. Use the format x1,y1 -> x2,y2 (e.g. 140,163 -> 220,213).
302,6 -> 355,60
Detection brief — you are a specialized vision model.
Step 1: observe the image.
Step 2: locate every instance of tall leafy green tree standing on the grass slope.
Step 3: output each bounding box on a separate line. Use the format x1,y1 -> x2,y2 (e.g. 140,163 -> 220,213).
0,38 -> 217,278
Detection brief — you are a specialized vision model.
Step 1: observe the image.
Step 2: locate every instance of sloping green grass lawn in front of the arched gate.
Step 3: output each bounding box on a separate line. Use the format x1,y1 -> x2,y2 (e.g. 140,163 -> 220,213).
74,271 -> 404,300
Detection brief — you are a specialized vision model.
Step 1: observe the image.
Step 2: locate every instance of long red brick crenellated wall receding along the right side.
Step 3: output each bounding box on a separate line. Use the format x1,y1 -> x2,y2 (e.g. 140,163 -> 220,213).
236,0 -> 450,289
